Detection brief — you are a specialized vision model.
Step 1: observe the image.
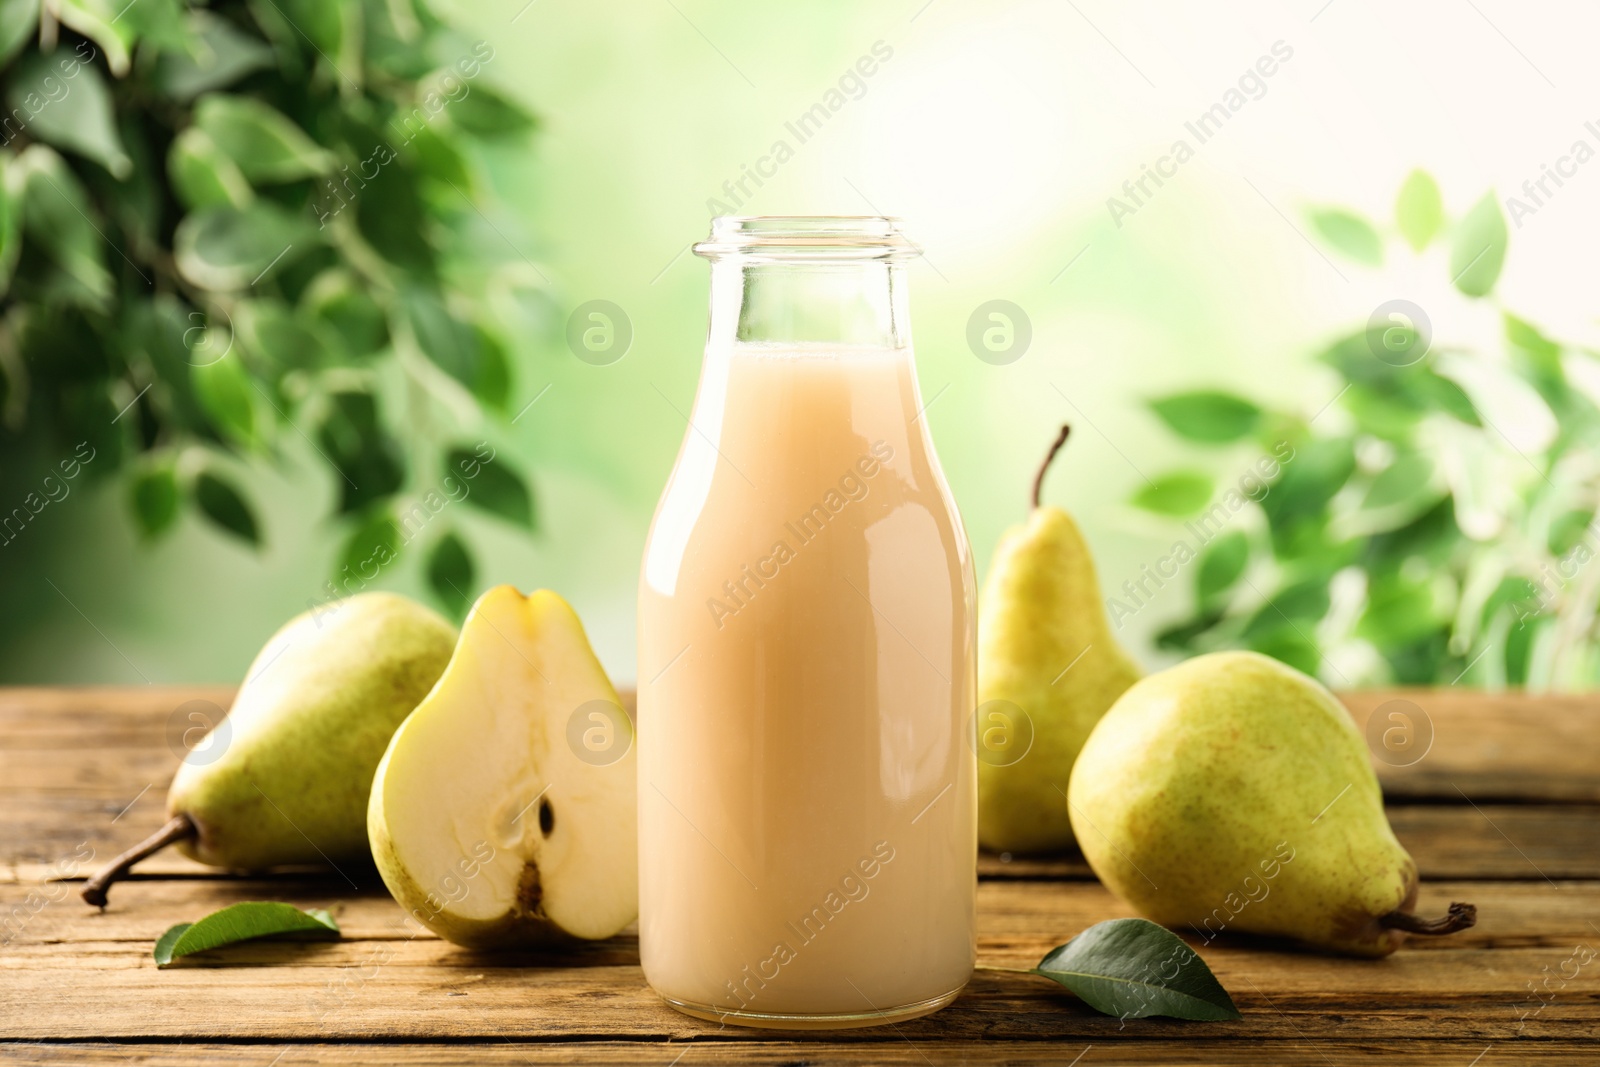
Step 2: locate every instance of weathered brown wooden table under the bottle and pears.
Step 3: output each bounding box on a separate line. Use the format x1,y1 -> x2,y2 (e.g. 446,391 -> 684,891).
0,686 -> 1600,1067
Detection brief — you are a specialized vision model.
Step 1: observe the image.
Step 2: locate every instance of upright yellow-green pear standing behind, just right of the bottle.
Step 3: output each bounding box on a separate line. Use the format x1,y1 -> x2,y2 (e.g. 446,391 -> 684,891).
976,427 -> 1139,853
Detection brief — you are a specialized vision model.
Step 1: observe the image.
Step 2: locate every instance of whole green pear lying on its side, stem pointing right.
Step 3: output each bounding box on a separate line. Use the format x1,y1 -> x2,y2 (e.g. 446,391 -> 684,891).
1067,653 -> 1477,957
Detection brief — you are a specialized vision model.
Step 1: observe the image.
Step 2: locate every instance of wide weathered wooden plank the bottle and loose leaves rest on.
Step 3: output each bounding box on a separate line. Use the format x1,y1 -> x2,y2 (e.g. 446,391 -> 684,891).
0,881 -> 1600,1041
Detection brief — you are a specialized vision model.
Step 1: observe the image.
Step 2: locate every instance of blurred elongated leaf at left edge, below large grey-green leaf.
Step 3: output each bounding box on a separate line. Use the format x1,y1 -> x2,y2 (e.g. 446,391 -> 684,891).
6,144 -> 112,306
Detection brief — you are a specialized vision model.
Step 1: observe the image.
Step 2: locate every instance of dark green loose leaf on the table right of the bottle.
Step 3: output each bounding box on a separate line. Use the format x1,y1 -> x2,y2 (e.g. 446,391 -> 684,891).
1034,918 -> 1240,1022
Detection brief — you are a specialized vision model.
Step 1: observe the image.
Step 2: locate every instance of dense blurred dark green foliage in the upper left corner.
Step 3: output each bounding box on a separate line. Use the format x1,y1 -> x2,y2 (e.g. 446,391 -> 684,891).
0,0 -> 544,614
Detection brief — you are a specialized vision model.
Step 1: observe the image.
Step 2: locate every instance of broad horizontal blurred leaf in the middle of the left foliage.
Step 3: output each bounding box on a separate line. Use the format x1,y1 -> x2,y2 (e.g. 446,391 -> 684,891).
173,200 -> 320,291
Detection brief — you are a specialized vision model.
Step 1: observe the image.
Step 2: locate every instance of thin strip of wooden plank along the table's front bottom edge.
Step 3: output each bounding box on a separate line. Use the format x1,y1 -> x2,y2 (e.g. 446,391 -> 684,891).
0,1043 -> 1597,1067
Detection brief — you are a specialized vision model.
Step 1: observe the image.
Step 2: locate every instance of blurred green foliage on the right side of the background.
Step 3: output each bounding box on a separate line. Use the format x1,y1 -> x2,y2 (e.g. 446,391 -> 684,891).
1133,171 -> 1600,689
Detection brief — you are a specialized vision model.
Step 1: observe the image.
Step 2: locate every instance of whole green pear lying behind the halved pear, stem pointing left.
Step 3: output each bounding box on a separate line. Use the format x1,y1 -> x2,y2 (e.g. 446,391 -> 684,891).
83,593 -> 456,907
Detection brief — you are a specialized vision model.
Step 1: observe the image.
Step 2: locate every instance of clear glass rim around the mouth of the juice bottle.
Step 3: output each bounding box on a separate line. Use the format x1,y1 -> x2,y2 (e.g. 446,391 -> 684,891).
694,214 -> 922,261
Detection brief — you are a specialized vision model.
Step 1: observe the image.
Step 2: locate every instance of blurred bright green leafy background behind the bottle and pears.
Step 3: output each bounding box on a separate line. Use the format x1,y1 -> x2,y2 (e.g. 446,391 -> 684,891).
0,0 -> 1600,688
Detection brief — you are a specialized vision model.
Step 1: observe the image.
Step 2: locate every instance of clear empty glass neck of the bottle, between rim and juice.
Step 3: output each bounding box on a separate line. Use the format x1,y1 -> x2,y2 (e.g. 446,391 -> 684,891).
707,254 -> 910,352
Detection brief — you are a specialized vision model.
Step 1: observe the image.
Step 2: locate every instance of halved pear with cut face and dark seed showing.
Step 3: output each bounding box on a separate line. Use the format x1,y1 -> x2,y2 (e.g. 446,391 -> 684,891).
366,585 -> 638,947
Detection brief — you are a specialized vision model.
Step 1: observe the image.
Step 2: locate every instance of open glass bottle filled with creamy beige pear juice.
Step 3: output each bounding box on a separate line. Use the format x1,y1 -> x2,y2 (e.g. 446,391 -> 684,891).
638,218 -> 978,1027
